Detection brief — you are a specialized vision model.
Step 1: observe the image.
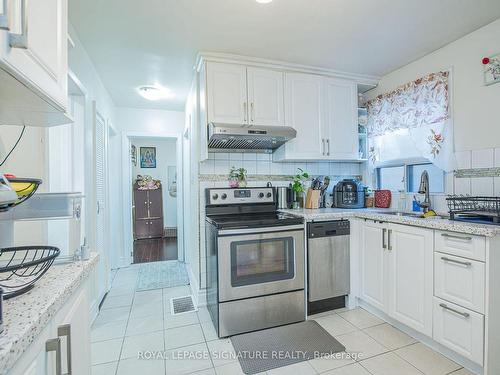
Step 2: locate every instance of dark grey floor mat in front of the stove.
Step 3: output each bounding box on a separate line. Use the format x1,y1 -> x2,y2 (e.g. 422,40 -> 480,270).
231,320 -> 345,374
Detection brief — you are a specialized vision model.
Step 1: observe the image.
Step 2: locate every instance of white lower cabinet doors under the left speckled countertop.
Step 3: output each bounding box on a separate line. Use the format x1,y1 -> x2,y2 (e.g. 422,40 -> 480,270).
9,280 -> 91,375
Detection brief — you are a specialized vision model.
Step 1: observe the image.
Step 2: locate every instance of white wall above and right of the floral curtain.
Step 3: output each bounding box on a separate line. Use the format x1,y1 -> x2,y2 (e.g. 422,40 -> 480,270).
367,19 -> 500,151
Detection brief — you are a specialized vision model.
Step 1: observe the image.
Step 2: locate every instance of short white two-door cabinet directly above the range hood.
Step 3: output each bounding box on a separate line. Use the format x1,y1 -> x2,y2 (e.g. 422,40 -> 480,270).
206,62 -> 285,126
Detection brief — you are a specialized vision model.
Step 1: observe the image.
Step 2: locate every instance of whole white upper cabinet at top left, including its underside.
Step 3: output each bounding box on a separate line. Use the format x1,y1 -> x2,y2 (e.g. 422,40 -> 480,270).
0,0 -> 68,126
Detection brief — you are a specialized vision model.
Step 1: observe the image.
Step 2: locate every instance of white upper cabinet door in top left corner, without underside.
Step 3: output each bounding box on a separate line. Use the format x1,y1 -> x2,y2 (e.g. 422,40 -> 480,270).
0,0 -> 68,110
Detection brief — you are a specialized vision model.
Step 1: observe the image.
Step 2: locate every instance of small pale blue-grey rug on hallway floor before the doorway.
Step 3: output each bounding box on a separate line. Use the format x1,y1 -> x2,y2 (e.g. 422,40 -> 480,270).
135,260 -> 189,292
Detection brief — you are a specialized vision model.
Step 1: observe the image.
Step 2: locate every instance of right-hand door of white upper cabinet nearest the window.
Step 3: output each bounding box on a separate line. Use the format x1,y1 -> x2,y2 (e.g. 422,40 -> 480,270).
324,79 -> 359,160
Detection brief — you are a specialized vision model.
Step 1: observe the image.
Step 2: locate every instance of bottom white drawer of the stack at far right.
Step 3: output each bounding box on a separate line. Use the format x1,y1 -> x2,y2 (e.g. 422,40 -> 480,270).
433,298 -> 484,366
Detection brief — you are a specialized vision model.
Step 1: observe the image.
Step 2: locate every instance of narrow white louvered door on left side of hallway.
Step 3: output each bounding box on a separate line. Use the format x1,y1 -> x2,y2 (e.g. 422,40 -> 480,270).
95,108 -> 110,301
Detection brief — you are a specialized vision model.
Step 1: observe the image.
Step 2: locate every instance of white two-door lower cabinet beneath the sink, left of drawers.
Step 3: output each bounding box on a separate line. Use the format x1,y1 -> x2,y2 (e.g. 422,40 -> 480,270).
360,222 -> 433,336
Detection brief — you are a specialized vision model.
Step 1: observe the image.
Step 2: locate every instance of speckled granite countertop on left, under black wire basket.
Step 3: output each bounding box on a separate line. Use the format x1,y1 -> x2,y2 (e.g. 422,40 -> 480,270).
0,253 -> 99,374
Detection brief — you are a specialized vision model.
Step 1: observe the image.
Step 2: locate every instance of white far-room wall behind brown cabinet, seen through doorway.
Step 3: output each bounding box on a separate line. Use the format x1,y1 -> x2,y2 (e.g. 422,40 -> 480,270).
130,138 -> 177,228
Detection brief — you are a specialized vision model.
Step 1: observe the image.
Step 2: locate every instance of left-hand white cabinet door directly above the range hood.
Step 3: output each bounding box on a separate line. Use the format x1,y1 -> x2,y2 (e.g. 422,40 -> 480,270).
207,62 -> 248,124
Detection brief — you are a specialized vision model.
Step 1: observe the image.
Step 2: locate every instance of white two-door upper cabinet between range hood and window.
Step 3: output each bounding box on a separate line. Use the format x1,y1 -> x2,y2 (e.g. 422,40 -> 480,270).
274,73 -> 359,161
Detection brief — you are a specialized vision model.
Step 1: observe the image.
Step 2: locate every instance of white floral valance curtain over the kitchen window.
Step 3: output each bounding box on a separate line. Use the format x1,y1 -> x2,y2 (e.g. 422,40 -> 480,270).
367,71 -> 454,171
